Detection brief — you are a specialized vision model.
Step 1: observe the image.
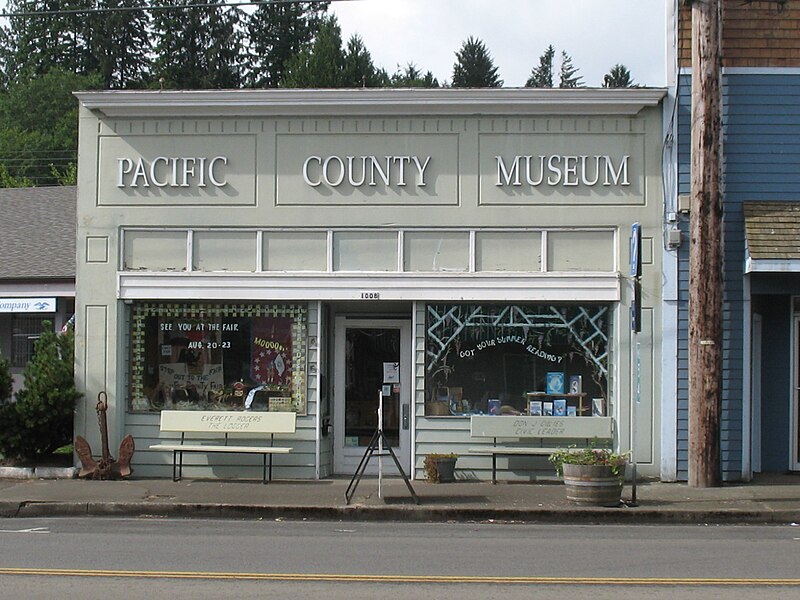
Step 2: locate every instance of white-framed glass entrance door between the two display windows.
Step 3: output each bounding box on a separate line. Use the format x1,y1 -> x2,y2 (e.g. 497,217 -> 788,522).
333,317 -> 411,474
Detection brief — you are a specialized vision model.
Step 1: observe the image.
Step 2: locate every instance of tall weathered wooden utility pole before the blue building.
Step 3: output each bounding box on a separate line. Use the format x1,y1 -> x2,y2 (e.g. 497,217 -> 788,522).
689,0 -> 723,487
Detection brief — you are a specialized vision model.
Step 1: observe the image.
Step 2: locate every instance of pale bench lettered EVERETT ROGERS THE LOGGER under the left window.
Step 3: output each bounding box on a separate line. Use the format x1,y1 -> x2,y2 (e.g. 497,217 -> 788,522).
150,410 -> 297,483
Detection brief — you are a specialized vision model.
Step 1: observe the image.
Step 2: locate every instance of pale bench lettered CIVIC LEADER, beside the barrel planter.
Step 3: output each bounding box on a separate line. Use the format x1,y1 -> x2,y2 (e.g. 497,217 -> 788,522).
469,415 -> 614,483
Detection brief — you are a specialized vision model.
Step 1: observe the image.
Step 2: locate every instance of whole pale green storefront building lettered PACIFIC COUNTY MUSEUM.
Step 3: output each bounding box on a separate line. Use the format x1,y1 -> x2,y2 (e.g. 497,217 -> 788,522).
76,89 -> 674,481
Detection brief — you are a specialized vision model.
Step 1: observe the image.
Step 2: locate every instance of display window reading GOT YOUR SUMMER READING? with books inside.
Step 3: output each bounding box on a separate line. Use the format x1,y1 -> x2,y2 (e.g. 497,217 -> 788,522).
425,304 -> 612,417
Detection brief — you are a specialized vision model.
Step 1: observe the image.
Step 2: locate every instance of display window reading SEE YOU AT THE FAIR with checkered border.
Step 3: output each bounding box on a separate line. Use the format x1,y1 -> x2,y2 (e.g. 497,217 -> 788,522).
130,303 -> 307,414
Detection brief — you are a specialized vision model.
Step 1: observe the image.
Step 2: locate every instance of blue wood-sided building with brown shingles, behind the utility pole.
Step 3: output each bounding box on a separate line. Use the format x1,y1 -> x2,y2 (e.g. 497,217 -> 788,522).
667,0 -> 800,480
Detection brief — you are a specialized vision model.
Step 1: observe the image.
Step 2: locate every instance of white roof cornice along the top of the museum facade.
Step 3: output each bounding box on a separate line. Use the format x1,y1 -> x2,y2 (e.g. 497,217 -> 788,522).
75,88 -> 666,118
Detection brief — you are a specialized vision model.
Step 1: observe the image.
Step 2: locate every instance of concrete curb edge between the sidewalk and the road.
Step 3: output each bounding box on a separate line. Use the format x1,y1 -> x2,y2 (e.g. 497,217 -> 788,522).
0,502 -> 800,525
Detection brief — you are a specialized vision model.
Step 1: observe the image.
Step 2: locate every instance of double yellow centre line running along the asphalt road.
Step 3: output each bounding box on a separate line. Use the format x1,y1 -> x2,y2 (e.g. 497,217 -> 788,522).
0,567 -> 800,586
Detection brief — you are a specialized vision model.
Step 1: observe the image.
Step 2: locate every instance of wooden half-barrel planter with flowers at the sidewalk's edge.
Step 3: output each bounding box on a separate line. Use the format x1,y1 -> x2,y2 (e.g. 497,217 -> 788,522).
549,447 -> 631,506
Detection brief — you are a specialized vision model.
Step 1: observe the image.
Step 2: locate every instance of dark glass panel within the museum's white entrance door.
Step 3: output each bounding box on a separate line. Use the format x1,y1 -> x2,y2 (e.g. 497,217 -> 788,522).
344,327 -> 400,447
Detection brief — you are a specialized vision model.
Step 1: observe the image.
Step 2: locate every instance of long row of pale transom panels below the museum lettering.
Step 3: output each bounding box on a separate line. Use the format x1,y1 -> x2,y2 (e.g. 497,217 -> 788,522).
120,228 -> 618,273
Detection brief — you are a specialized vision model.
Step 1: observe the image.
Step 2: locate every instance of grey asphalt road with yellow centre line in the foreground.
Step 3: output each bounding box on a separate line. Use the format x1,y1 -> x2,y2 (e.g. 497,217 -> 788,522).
0,518 -> 800,600
